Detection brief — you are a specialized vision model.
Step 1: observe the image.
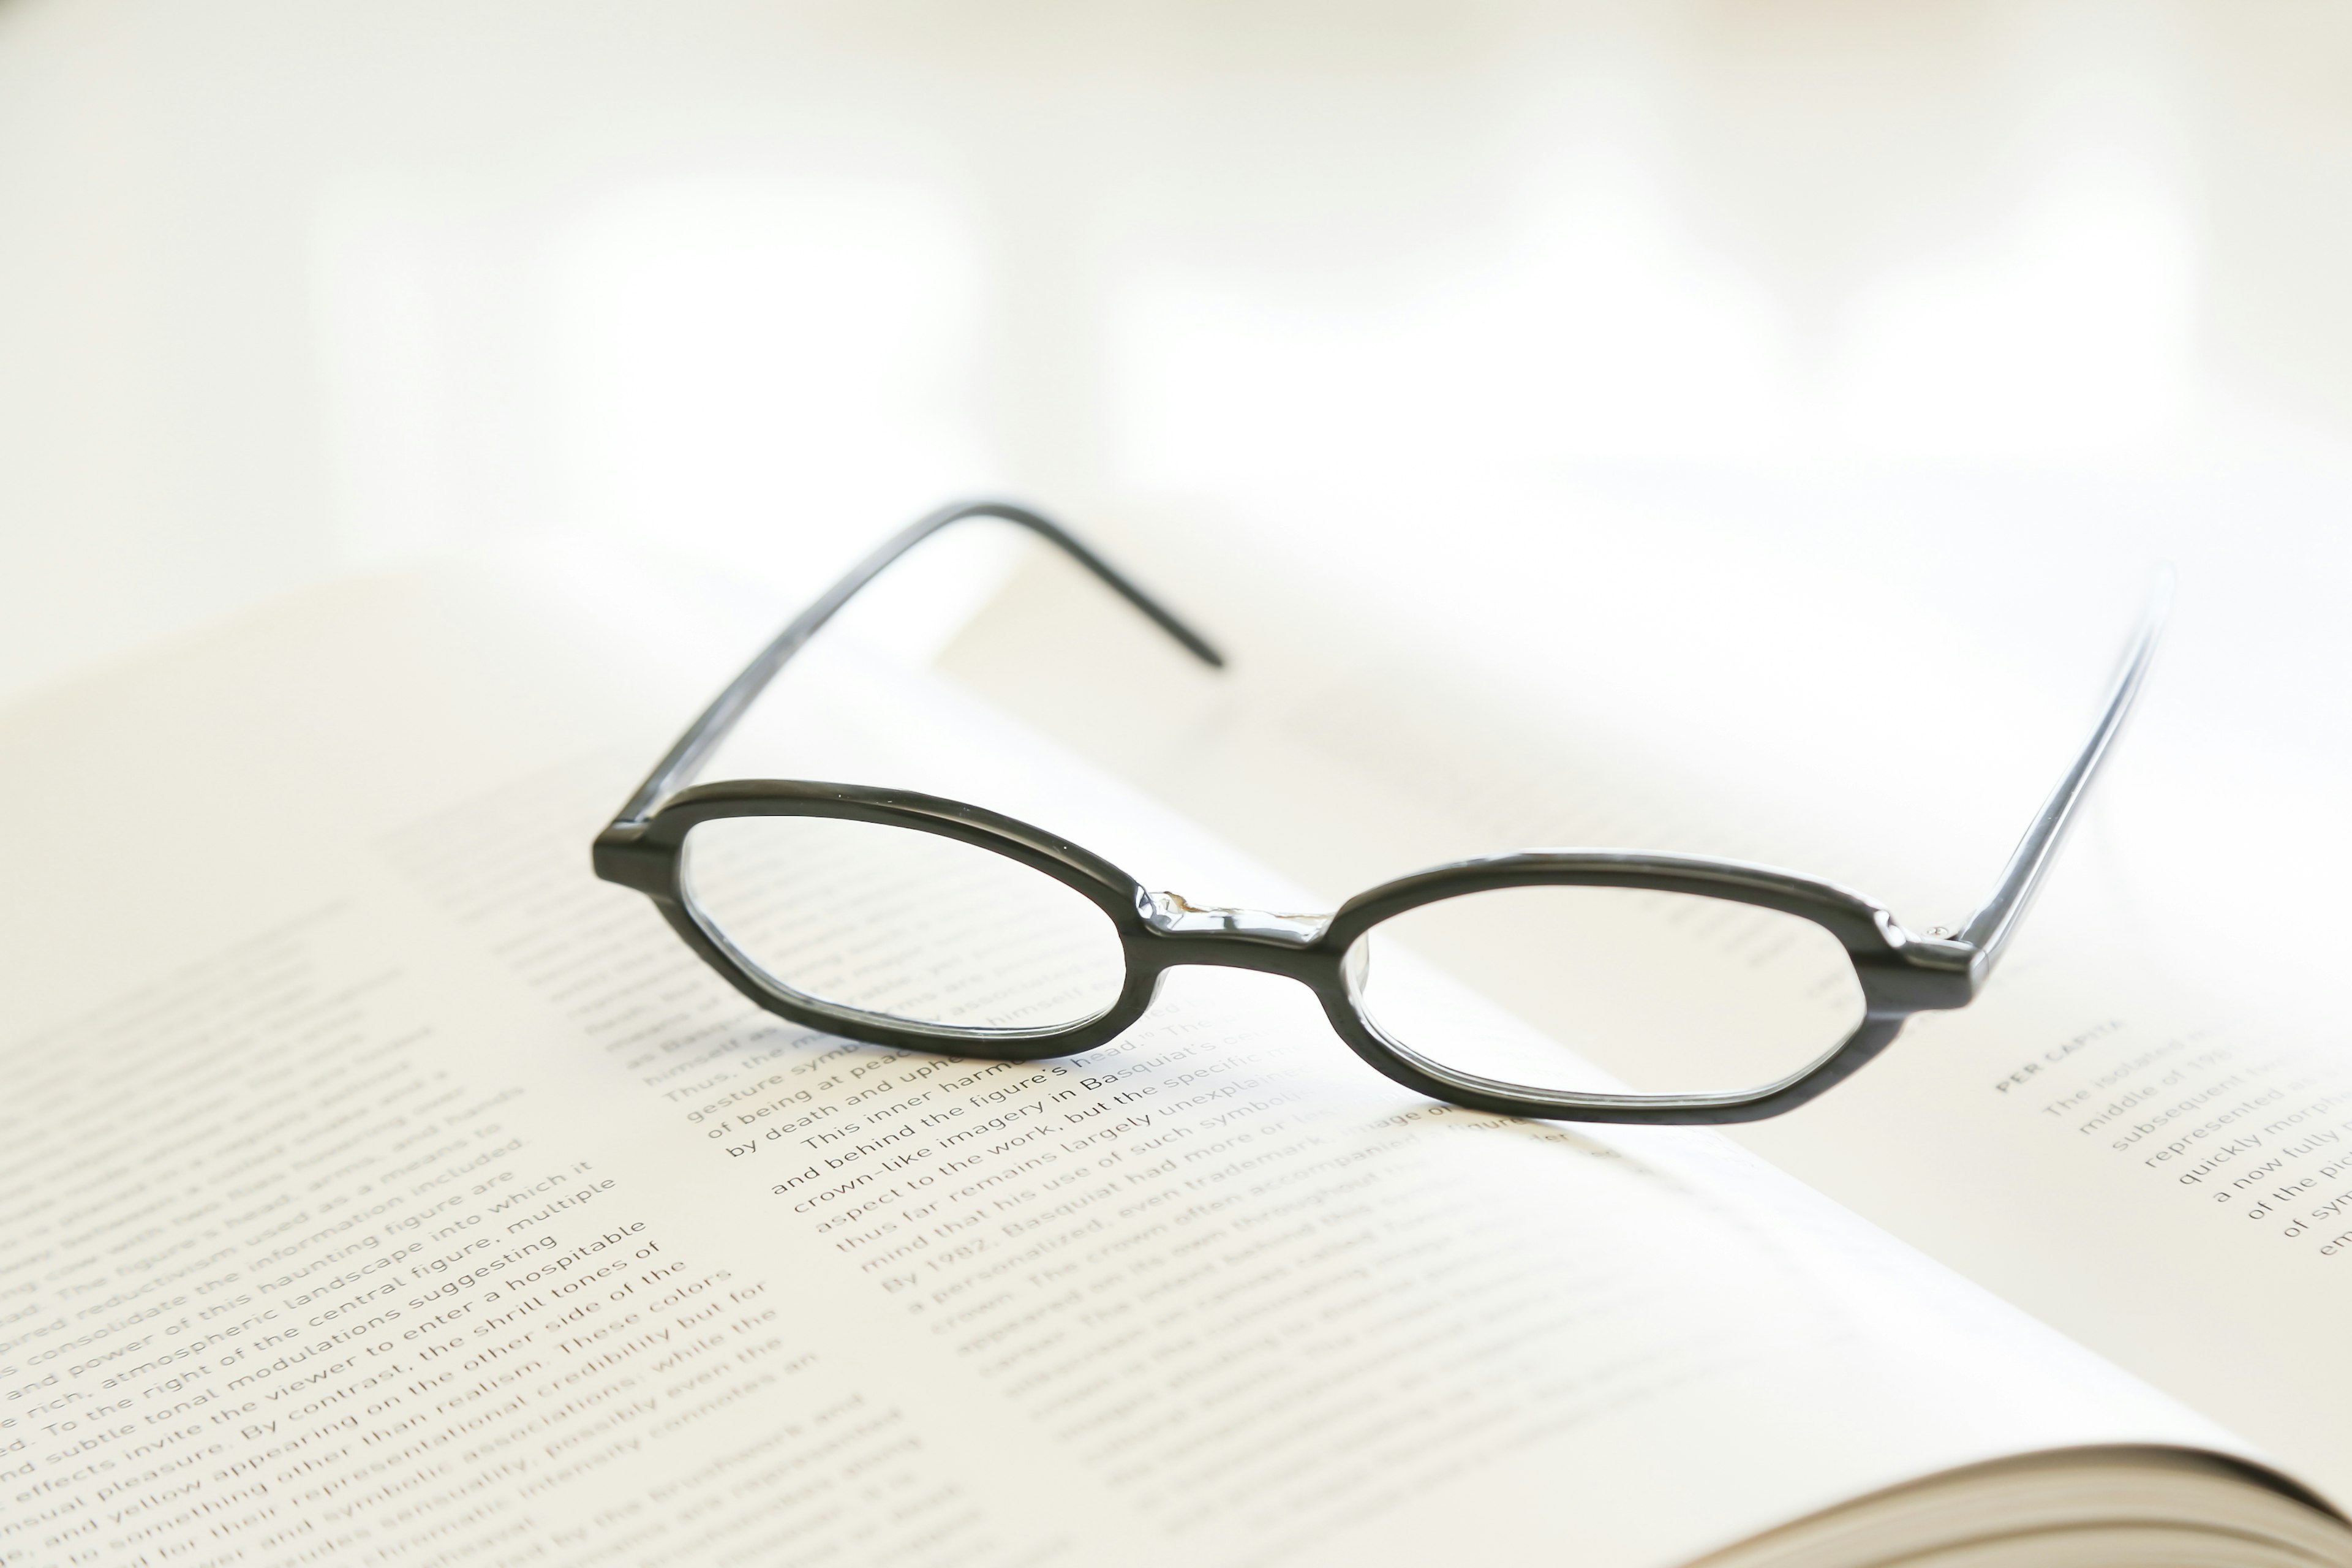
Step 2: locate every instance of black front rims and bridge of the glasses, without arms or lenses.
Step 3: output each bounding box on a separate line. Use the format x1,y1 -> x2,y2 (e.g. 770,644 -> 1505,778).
597,778 -> 1973,1124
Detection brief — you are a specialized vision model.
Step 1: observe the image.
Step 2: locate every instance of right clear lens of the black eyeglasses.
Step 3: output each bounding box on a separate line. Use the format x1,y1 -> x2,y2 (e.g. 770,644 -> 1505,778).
1348,886 -> 1863,1096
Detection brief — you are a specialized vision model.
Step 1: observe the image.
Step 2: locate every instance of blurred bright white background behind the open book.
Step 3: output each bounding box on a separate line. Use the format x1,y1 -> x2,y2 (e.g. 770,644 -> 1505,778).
0,0 -> 2352,832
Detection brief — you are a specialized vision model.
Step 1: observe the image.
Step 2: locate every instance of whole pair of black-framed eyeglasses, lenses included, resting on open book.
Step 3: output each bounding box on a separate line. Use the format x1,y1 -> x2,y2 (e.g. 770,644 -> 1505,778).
593,501 -> 2171,1124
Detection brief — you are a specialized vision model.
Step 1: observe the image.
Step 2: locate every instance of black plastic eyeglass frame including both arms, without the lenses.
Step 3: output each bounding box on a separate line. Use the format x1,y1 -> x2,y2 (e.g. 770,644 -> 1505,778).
593,501 -> 2171,1124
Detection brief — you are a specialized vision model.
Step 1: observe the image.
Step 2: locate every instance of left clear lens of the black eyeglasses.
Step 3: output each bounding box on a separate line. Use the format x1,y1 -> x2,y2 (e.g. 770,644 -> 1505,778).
684,816 -> 1126,1030
